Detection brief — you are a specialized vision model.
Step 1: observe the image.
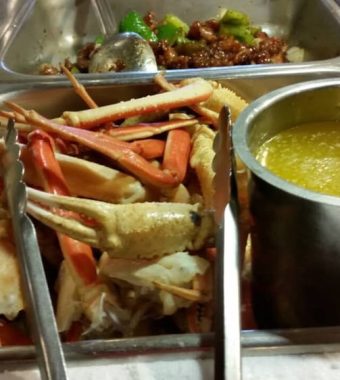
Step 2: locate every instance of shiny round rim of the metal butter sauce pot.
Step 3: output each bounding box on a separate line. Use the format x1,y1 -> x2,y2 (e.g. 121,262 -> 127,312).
232,78 -> 340,206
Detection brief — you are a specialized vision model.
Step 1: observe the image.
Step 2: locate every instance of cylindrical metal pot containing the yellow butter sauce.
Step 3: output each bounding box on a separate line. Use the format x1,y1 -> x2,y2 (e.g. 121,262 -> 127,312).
233,79 -> 340,328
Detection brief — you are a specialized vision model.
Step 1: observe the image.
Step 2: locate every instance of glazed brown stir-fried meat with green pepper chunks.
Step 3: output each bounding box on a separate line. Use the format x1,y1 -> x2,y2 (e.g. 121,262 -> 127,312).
39,10 -> 288,75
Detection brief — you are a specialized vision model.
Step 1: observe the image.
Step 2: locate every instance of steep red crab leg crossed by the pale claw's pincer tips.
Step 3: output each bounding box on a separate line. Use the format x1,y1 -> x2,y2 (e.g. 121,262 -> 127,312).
29,131 -> 133,331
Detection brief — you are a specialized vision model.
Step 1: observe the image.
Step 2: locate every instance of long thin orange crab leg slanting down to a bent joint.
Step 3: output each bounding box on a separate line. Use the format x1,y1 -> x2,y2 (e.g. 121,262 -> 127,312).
6,102 -> 188,187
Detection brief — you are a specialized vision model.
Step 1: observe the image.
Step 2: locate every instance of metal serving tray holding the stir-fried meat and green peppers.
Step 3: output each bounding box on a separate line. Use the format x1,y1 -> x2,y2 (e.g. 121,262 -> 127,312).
0,0 -> 340,82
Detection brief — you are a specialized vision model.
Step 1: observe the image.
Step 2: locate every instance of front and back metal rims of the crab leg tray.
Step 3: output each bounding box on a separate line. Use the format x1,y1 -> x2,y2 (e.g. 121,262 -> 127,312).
0,66 -> 340,362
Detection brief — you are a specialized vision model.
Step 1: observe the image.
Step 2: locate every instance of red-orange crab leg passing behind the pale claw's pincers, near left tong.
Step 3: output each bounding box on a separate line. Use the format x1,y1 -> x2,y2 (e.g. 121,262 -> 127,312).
28,130 -> 137,331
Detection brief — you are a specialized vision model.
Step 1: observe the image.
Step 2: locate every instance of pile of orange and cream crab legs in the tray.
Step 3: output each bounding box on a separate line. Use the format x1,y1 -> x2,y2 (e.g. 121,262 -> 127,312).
1,68 -> 250,339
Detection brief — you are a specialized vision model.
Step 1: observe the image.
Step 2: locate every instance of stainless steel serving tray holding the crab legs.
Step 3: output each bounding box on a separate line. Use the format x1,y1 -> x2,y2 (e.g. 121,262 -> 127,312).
0,66 -> 340,363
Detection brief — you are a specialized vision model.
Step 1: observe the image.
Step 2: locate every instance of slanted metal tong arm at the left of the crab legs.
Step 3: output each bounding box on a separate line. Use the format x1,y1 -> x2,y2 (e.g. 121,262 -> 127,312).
2,119 -> 67,380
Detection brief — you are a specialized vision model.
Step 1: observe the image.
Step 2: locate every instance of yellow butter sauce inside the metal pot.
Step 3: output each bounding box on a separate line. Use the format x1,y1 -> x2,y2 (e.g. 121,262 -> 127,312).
256,122 -> 340,196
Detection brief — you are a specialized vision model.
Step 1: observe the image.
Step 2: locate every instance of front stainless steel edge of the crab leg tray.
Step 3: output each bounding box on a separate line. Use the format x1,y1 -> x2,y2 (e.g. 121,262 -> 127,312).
0,327 -> 340,365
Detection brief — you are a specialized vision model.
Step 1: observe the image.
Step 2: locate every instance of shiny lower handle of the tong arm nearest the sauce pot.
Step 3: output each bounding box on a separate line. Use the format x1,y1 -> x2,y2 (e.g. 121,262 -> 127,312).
215,203 -> 242,380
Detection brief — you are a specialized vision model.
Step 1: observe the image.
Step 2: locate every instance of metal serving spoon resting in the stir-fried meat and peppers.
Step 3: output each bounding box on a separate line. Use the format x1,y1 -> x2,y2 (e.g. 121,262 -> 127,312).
89,0 -> 157,73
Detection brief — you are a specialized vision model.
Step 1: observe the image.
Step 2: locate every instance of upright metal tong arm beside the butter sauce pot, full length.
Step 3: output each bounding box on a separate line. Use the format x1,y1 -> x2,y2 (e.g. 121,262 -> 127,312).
213,106 -> 242,380
